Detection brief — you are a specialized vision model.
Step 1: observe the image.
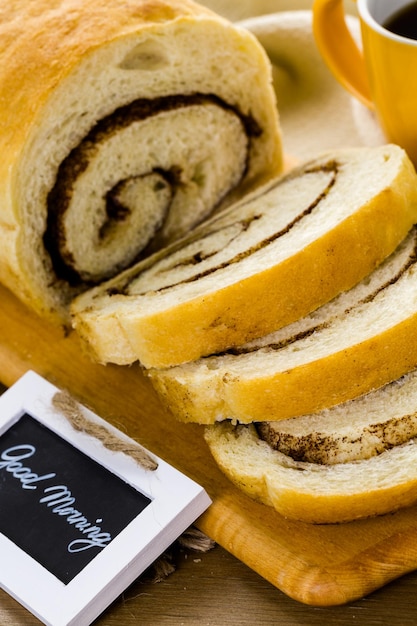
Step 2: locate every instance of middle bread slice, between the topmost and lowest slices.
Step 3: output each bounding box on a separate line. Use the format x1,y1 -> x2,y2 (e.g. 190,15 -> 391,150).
149,222 -> 417,424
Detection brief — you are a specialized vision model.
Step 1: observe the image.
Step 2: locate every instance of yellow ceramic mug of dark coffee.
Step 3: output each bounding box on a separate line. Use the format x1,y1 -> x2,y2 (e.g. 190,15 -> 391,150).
313,0 -> 417,165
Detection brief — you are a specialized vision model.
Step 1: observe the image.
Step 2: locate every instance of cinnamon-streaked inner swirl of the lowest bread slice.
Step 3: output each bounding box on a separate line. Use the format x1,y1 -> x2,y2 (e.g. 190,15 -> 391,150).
255,371 -> 417,465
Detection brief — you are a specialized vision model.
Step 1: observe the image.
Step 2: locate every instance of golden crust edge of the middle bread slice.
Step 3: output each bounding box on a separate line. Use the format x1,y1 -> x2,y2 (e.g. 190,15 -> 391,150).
149,296 -> 417,424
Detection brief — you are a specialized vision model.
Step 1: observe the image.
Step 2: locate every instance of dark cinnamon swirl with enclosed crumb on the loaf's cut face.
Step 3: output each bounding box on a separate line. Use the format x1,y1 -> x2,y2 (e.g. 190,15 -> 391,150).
43,94 -> 261,286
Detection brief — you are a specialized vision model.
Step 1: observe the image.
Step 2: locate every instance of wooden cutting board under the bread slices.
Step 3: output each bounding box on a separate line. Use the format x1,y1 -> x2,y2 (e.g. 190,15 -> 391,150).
0,286 -> 417,606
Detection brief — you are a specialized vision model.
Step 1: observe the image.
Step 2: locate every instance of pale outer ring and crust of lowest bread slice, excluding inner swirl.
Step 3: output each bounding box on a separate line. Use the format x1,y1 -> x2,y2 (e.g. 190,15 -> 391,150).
205,408 -> 417,524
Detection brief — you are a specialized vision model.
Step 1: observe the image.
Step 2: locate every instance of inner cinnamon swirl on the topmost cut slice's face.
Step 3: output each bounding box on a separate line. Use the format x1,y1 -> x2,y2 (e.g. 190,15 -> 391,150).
108,161 -> 338,295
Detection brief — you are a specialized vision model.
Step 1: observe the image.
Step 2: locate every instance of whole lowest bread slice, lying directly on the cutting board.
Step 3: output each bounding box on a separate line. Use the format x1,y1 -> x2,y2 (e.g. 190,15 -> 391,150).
205,348 -> 417,523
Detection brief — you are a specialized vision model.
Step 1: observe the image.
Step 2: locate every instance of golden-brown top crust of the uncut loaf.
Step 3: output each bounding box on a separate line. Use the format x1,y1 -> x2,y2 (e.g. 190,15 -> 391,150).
0,0 -> 213,151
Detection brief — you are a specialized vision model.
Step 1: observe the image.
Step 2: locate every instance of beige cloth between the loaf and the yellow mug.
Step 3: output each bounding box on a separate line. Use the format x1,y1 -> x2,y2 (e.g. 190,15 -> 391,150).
200,0 -> 386,161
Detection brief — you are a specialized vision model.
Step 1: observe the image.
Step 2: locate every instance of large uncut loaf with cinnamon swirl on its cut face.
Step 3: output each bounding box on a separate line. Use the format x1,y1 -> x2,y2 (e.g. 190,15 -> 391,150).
0,0 -> 282,320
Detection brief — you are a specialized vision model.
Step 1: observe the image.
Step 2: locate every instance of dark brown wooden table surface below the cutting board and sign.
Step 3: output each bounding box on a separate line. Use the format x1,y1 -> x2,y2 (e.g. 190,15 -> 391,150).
0,372 -> 417,626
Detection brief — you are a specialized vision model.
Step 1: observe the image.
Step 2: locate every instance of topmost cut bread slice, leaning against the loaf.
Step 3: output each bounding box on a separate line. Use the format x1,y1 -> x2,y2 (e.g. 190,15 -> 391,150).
72,145 -> 417,366
